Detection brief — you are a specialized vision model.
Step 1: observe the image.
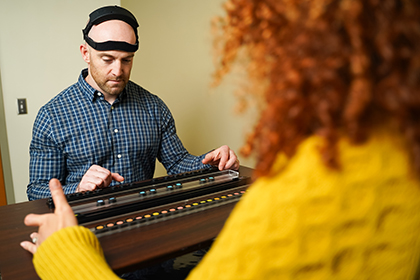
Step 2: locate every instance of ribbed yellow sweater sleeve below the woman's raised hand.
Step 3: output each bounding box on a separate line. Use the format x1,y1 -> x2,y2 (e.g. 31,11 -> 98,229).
33,226 -> 120,280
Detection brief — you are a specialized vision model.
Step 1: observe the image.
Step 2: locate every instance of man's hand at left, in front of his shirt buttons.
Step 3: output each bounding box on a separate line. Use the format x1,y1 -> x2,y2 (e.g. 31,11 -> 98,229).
76,165 -> 124,192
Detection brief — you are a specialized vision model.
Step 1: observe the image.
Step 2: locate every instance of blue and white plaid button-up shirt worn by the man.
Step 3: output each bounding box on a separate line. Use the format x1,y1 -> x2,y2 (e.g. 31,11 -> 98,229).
27,69 -> 205,200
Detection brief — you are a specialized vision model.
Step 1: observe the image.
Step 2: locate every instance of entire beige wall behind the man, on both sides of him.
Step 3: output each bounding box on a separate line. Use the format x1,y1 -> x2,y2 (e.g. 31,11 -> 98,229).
0,0 -> 253,203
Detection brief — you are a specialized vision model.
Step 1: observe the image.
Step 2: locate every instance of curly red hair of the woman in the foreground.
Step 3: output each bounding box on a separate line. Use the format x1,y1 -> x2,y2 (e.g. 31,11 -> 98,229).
215,0 -> 420,176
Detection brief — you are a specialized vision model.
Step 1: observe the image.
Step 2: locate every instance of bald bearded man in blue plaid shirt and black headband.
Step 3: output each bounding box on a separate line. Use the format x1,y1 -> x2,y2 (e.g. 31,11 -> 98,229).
27,6 -> 239,200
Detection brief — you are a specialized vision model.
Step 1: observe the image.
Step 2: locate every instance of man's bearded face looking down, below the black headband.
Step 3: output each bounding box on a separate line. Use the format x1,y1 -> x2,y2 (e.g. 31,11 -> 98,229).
89,48 -> 134,97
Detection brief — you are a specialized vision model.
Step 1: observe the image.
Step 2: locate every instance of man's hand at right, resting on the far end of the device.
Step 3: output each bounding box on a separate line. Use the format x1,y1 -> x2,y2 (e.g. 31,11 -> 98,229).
202,145 -> 239,170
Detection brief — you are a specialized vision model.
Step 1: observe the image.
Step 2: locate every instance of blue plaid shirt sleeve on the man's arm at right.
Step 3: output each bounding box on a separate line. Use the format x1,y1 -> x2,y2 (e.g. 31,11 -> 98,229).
158,97 -> 210,175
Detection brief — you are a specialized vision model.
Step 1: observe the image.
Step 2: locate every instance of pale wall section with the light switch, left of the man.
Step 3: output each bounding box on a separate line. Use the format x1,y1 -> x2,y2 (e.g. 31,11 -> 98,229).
0,0 -> 120,203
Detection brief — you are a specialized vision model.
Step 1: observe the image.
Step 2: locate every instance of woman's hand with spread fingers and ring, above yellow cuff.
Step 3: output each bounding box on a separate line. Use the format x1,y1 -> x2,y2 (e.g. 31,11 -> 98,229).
20,179 -> 77,254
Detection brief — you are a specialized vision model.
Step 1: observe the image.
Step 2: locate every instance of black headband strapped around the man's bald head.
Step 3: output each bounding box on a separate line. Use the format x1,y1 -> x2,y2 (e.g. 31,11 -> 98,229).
82,6 -> 139,52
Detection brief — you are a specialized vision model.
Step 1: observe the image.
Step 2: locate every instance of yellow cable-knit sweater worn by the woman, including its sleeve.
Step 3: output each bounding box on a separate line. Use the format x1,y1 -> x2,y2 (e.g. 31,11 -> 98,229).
34,133 -> 420,280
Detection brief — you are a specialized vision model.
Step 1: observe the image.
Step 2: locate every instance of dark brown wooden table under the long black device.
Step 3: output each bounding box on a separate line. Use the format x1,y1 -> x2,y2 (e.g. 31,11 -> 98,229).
0,166 -> 252,280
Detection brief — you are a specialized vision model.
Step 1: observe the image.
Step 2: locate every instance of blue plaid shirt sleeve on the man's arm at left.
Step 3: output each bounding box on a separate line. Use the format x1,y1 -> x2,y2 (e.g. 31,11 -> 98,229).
26,108 -> 77,200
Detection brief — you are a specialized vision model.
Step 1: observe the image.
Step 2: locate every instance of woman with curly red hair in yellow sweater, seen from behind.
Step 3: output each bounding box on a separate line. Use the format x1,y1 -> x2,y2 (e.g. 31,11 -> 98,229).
22,0 -> 420,279
